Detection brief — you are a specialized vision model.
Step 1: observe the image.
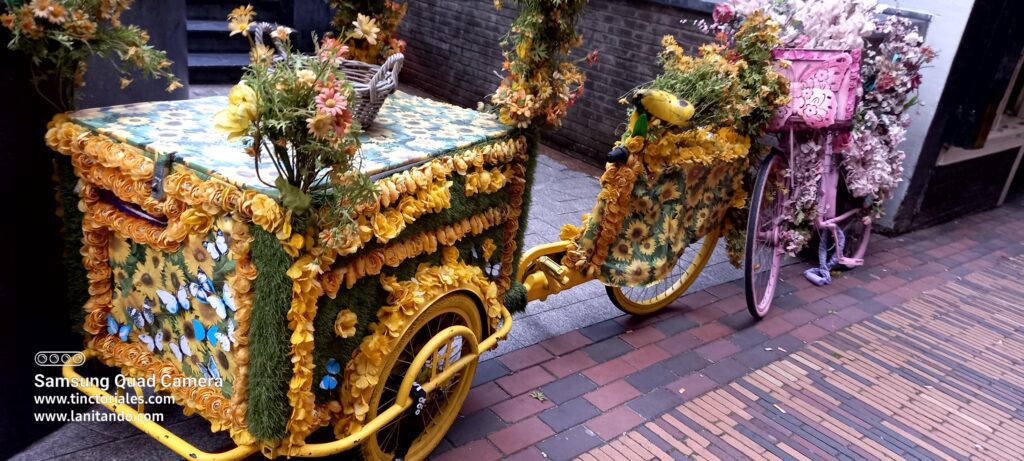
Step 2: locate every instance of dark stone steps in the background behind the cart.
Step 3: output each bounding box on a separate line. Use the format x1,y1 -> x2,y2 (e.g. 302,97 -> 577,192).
185,0 -> 283,84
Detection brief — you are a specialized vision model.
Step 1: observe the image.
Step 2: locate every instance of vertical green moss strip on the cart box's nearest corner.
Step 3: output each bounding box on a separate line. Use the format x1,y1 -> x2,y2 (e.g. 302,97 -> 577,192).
246,225 -> 292,441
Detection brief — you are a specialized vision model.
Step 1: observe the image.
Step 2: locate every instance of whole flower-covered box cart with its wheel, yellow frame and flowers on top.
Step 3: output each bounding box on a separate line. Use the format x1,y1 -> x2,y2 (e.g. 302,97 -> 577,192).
46,1 -> 583,459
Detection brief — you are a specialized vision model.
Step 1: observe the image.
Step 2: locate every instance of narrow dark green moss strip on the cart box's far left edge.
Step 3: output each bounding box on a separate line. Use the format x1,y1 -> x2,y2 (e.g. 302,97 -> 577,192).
54,156 -> 89,332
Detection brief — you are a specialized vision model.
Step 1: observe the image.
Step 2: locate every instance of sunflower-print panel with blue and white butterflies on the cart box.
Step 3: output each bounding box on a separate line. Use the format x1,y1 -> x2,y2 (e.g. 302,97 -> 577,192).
106,218 -> 238,397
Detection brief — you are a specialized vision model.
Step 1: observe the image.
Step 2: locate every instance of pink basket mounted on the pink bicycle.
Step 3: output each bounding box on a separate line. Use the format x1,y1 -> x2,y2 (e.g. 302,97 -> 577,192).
768,48 -> 860,131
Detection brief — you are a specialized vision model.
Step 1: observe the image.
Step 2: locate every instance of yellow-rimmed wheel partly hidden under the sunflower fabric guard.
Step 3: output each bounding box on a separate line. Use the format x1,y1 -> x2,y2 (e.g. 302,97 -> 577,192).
605,229 -> 719,316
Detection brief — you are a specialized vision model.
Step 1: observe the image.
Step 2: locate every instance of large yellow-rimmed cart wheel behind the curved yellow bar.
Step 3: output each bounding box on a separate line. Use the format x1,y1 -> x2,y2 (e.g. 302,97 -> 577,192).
362,294 -> 483,461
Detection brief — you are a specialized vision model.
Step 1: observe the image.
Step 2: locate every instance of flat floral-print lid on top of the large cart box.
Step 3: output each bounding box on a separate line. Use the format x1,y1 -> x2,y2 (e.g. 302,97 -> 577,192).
71,91 -> 512,195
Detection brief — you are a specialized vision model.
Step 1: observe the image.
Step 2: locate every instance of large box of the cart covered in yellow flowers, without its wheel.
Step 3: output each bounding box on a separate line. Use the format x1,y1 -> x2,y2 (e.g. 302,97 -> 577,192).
47,92 -> 531,455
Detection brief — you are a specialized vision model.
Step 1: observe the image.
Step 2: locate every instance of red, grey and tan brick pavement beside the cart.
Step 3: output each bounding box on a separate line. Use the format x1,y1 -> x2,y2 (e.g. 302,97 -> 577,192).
434,200 -> 1024,461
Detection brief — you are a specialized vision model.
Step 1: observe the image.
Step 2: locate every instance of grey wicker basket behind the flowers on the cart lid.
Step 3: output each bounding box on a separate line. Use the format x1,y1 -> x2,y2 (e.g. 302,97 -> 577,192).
341,53 -> 404,129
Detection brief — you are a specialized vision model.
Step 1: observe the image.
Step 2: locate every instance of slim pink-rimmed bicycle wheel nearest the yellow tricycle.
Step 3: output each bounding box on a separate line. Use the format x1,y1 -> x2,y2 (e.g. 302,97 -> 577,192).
743,153 -> 785,320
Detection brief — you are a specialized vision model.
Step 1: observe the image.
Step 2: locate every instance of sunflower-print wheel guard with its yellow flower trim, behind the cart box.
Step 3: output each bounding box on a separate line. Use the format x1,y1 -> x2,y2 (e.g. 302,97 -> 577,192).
562,128 -> 751,287
